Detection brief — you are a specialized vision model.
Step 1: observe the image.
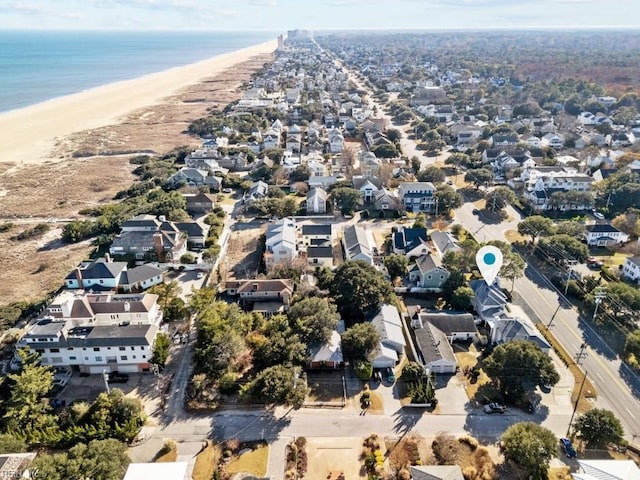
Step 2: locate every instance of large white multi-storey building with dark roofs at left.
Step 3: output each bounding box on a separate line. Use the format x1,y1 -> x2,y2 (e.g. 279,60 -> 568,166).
17,292 -> 162,373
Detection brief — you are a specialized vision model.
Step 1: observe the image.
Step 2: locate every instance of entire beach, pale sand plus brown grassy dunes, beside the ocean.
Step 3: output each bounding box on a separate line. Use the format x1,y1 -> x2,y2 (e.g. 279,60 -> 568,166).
0,41 -> 276,305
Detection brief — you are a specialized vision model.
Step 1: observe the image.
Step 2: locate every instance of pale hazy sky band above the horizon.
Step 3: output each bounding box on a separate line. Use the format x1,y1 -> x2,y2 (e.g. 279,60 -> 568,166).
0,0 -> 640,31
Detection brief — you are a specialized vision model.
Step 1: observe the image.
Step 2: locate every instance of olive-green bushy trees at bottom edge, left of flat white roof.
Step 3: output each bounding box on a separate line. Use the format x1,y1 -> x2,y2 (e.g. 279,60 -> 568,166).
30,439 -> 130,480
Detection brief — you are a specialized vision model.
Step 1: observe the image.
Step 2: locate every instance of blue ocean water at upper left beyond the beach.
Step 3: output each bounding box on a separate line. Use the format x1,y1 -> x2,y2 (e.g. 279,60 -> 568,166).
0,31 -> 278,112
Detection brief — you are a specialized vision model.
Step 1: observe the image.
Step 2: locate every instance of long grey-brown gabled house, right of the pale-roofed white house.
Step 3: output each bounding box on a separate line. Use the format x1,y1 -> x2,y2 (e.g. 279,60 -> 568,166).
409,307 -> 458,374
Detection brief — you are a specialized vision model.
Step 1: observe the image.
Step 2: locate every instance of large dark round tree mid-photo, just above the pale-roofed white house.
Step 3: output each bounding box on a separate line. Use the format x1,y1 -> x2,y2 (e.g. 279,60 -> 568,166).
329,260 -> 395,320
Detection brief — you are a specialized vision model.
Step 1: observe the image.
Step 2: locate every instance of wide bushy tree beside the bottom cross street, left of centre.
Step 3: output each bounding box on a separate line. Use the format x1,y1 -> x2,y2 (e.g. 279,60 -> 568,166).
240,365 -> 308,410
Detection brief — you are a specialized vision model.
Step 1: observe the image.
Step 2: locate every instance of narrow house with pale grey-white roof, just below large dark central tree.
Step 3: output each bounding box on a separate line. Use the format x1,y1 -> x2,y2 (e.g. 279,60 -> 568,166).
371,304 -> 406,368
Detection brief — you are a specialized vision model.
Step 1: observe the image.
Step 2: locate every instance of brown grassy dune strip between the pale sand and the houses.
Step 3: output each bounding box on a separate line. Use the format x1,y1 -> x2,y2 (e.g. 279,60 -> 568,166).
0,54 -> 272,305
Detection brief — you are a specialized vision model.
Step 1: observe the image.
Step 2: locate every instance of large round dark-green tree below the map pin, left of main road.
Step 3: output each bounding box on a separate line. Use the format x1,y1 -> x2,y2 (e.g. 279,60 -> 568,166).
484,340 -> 560,401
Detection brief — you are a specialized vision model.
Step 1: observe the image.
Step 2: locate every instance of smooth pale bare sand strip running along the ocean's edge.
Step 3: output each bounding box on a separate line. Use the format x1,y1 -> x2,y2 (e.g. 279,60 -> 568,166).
0,40 -> 276,166
